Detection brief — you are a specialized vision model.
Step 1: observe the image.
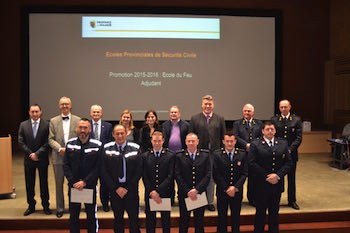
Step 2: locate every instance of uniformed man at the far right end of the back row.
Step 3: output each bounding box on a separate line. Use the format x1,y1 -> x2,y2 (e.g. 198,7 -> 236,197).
271,100 -> 303,210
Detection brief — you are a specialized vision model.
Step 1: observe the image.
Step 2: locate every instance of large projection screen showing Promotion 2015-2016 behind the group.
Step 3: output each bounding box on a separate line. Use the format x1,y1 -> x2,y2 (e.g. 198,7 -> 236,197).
28,13 -> 278,121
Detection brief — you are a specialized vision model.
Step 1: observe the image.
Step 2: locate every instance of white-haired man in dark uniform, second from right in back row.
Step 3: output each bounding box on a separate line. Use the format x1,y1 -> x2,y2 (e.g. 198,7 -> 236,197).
233,104 -> 262,206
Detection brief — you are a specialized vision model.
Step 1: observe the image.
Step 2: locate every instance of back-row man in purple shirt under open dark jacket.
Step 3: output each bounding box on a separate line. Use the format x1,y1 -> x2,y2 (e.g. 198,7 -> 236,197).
162,105 -> 190,203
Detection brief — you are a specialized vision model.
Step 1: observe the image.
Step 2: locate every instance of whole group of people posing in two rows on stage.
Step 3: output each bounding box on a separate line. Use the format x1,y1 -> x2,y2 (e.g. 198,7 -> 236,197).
18,95 -> 302,233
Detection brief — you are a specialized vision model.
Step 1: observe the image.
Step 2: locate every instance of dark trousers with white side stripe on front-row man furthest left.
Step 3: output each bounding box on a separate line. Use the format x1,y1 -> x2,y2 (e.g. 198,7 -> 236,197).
68,187 -> 98,233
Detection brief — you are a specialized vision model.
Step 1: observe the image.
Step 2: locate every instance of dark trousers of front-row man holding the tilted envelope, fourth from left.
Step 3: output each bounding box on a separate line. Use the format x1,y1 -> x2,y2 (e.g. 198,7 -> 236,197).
179,197 -> 205,233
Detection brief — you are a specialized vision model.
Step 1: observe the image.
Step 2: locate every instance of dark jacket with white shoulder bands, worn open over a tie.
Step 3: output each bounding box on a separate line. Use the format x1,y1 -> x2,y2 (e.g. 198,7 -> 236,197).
101,142 -> 143,195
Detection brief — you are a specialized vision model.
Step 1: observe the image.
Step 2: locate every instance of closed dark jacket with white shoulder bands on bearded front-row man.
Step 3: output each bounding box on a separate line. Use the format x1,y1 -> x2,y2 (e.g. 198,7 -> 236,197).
63,138 -> 102,188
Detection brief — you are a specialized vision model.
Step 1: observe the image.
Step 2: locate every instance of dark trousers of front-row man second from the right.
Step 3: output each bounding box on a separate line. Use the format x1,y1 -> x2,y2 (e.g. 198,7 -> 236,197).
217,193 -> 242,233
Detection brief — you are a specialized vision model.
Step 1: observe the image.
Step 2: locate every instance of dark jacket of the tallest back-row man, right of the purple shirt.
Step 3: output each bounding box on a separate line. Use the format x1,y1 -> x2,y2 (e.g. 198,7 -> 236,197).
189,112 -> 226,151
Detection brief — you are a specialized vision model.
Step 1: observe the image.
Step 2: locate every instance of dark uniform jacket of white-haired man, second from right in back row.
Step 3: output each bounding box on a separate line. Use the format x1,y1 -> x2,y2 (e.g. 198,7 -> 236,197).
233,118 -> 263,150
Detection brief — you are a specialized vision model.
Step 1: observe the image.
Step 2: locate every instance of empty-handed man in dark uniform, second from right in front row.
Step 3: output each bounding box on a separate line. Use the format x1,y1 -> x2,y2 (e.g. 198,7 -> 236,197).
213,132 -> 248,233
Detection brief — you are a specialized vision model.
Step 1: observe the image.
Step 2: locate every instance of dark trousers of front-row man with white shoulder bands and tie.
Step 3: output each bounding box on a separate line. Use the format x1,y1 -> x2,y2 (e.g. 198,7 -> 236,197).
111,190 -> 140,233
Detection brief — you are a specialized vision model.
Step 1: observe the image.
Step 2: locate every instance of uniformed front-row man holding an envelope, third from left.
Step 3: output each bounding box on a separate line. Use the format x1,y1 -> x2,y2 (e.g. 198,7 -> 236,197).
142,131 -> 175,233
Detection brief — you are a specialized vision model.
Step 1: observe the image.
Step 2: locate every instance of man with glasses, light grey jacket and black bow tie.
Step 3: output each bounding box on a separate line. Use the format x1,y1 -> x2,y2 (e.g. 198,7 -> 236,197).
49,96 -> 80,218
